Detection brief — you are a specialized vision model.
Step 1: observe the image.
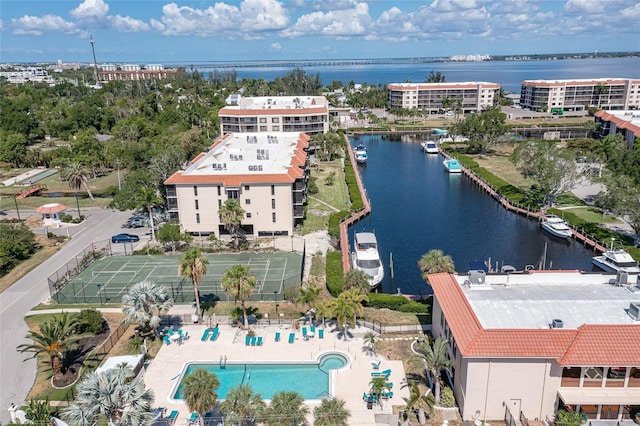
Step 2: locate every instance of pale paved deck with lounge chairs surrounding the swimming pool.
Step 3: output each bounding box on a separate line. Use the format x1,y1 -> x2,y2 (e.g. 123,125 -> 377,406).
144,324 -> 409,425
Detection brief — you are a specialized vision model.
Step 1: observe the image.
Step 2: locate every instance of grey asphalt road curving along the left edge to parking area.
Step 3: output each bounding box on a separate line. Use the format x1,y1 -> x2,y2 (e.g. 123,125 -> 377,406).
0,208 -> 135,424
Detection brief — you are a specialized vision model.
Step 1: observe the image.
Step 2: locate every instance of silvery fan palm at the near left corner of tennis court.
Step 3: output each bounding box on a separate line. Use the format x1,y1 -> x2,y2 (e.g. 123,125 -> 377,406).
122,281 -> 173,336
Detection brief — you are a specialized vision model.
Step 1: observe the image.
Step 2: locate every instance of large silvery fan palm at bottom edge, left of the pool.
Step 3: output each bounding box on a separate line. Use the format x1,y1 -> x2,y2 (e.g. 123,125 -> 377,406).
62,366 -> 155,426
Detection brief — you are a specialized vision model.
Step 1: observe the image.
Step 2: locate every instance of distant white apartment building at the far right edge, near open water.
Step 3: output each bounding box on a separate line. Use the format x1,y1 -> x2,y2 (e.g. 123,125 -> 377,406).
520,78 -> 640,112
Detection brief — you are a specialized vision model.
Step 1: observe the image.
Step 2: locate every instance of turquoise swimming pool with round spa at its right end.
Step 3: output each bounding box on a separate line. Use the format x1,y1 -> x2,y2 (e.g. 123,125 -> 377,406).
171,352 -> 350,401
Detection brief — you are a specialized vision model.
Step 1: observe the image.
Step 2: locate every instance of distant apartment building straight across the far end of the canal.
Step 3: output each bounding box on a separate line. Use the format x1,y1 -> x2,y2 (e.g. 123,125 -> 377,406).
387,82 -> 500,114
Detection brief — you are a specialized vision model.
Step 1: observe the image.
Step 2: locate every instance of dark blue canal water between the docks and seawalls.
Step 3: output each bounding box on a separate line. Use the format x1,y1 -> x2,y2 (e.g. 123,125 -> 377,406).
349,135 -> 593,295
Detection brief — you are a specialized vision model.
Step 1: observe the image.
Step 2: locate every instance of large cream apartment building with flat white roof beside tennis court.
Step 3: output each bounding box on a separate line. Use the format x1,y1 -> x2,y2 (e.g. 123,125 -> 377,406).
165,132 -> 310,237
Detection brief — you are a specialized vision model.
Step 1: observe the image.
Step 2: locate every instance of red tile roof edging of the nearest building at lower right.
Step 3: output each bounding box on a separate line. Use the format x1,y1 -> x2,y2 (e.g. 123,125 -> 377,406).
429,273 -> 640,366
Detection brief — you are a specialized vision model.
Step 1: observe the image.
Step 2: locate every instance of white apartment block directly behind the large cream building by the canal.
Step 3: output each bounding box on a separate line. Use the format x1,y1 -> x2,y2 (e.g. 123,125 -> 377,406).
218,96 -> 329,135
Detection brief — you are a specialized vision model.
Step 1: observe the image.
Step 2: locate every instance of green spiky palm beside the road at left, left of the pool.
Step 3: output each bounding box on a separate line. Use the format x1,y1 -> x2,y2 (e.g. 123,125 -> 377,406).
17,312 -> 85,378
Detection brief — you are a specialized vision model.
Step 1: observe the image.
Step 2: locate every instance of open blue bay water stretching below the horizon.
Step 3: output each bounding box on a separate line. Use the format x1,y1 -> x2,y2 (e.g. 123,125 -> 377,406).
198,58 -> 640,93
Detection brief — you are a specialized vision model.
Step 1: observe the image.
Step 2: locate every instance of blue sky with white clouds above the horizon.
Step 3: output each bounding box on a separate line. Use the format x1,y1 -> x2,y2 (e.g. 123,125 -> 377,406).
0,0 -> 640,64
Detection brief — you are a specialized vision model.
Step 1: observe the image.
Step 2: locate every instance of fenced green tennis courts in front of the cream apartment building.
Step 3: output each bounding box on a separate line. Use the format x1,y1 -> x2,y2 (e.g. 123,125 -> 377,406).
54,253 -> 303,304
